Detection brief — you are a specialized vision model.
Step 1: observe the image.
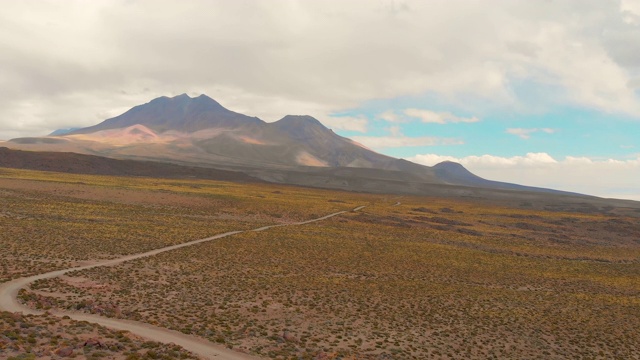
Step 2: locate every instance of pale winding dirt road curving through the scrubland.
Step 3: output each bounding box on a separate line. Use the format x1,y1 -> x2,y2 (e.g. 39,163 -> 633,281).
0,206 -> 364,360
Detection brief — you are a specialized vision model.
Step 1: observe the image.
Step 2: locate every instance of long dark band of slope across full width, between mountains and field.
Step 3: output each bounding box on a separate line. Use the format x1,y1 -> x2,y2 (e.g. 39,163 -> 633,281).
0,147 -> 640,217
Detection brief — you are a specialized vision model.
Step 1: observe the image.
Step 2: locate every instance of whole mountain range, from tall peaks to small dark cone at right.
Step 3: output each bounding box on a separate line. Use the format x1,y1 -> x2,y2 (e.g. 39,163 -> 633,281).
0,94 -> 568,193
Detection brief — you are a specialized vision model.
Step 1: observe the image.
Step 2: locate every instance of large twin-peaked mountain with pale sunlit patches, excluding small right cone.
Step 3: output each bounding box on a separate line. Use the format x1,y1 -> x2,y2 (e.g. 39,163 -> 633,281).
21,94 -> 435,177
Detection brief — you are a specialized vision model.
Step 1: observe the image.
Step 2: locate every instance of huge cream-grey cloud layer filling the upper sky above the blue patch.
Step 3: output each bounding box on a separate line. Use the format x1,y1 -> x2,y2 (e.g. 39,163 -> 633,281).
0,0 -> 640,135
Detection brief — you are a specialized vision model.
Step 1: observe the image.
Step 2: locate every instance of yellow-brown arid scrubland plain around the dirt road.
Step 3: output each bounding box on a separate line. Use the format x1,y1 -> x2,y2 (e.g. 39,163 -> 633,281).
0,169 -> 640,359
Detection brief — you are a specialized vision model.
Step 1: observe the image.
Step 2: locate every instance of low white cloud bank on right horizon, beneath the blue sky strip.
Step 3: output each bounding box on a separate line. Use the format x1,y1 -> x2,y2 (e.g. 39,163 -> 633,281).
407,153 -> 640,200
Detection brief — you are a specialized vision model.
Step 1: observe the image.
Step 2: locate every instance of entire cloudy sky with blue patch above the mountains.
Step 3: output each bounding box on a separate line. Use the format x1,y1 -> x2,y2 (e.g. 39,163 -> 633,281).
0,0 -> 640,200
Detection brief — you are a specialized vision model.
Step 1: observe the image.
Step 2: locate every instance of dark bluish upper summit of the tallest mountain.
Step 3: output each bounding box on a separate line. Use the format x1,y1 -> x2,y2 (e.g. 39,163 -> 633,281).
68,94 -> 263,134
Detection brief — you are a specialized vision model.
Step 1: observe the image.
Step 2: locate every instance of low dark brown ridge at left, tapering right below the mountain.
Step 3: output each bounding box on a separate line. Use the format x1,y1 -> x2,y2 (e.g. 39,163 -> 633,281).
0,147 -> 261,182
